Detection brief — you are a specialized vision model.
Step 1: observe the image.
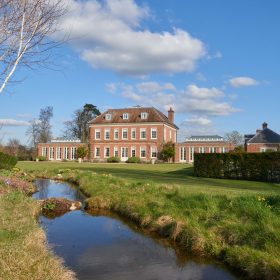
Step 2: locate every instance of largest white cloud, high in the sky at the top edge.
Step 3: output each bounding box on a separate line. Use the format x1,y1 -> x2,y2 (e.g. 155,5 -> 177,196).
57,0 -> 206,76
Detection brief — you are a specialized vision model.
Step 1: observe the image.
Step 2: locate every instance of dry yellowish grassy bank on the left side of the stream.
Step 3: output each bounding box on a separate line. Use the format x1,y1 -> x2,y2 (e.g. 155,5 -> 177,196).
0,172 -> 74,280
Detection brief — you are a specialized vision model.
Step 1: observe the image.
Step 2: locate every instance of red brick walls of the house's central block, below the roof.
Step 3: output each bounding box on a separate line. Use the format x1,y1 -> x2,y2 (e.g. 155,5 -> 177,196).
90,123 -> 177,161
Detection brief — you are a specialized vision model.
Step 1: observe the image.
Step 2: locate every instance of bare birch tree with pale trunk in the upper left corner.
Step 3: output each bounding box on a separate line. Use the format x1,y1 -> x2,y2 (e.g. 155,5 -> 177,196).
0,0 -> 66,94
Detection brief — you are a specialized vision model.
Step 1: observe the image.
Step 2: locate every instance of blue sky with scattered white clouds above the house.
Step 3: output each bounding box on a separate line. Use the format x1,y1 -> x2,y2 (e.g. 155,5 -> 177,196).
0,0 -> 280,144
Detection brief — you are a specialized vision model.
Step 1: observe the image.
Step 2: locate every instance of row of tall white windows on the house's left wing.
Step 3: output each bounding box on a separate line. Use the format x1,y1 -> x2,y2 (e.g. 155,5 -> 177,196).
42,147 -> 77,160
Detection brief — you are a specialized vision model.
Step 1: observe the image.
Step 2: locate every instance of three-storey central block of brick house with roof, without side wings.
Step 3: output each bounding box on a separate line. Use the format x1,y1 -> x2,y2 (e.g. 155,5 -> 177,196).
89,107 -> 178,161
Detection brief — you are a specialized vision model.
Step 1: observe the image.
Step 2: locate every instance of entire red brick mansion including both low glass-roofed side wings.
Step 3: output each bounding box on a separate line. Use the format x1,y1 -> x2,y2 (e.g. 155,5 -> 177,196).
38,106 -> 234,163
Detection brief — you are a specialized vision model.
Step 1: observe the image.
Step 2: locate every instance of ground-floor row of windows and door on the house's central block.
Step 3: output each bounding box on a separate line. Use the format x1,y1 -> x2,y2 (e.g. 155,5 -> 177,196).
94,147 -> 157,158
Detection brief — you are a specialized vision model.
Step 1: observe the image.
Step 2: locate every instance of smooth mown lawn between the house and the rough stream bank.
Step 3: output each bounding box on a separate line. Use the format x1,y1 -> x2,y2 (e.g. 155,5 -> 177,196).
17,162 -> 280,195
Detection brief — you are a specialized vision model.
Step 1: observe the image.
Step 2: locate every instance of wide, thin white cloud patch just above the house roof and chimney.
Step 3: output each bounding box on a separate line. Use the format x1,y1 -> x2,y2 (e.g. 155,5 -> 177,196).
112,82 -> 240,116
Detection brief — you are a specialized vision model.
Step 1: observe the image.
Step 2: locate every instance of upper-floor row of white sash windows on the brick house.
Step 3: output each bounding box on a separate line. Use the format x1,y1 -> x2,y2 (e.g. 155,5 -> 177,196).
95,128 -> 157,140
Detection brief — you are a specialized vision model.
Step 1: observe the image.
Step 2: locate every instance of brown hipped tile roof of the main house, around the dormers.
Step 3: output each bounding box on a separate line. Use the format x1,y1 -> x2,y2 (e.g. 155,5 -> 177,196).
89,106 -> 179,129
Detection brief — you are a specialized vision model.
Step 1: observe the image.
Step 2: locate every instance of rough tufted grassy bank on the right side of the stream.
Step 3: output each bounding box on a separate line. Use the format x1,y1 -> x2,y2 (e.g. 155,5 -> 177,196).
29,166 -> 280,280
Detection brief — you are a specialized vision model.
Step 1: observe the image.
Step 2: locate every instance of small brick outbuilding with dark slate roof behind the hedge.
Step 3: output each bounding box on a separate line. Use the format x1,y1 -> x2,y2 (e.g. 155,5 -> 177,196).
244,122 -> 280,153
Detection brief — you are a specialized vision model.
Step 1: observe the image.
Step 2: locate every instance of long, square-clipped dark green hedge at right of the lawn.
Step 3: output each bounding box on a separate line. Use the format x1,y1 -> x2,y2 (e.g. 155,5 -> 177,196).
194,152 -> 280,183
